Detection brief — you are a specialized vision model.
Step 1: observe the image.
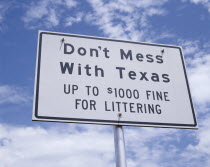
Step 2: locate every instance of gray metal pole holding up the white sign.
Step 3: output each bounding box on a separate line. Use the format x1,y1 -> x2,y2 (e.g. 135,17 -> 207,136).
114,125 -> 127,167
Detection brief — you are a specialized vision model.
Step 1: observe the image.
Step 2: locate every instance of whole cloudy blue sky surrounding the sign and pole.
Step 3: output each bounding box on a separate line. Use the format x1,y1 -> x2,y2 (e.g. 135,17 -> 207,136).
0,0 -> 210,167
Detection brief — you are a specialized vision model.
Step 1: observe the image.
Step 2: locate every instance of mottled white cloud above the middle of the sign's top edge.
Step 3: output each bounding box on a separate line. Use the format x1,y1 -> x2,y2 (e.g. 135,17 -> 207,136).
86,0 -> 167,41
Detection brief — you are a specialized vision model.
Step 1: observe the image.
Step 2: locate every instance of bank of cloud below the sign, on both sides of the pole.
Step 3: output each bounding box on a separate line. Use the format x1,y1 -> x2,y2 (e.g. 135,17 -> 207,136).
0,119 -> 210,167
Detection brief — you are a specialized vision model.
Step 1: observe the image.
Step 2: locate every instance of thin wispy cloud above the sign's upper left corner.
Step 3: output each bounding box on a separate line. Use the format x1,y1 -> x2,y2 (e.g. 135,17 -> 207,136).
23,0 -> 77,28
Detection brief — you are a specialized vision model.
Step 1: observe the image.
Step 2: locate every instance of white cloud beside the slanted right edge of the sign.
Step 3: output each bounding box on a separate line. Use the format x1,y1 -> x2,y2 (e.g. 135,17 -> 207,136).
178,39 -> 210,108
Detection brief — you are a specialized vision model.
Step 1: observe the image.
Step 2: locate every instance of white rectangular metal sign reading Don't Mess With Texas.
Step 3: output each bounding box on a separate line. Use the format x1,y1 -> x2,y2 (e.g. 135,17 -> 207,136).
33,31 -> 197,128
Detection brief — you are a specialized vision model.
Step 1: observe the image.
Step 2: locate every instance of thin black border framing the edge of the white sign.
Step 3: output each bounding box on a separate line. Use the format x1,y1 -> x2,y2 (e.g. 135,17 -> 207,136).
34,31 -> 197,128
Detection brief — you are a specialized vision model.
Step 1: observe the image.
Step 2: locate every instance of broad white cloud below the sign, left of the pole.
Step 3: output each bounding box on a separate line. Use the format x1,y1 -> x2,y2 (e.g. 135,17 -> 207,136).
0,125 -> 114,167
